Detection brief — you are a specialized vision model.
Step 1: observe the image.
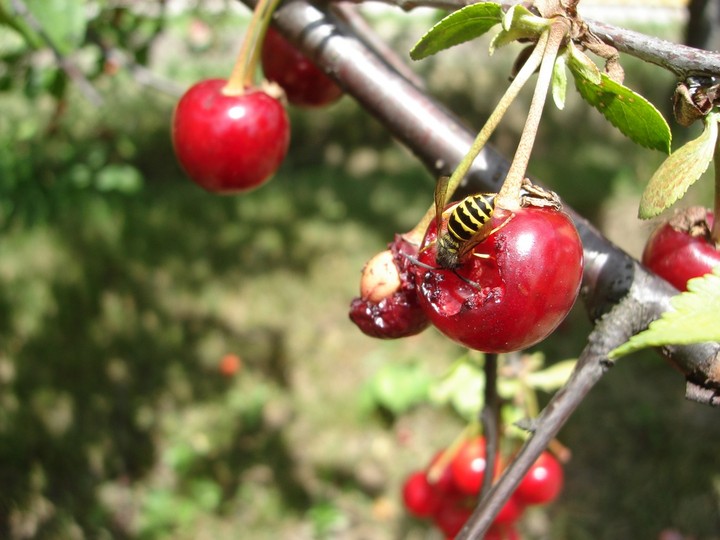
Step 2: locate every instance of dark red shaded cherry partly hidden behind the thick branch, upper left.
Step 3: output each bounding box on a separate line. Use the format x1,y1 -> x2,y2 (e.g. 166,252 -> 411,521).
262,28 -> 343,107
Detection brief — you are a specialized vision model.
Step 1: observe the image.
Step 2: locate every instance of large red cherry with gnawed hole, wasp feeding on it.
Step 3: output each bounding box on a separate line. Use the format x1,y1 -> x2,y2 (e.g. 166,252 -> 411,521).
416,207 -> 583,353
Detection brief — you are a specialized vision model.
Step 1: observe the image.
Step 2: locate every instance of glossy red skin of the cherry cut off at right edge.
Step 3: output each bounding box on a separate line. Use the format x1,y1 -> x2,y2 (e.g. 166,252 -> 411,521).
642,211 -> 720,291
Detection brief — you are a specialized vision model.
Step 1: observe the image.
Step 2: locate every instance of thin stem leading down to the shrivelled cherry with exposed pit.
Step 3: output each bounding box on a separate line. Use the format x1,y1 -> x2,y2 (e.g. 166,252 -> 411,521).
405,31 -> 548,238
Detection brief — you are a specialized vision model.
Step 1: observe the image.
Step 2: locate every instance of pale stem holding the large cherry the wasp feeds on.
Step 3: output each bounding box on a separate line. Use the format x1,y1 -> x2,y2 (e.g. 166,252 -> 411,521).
495,19 -> 569,211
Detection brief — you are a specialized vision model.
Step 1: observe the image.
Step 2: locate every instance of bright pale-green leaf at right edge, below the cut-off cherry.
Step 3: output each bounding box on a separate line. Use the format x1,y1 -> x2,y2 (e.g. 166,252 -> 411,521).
608,265 -> 720,359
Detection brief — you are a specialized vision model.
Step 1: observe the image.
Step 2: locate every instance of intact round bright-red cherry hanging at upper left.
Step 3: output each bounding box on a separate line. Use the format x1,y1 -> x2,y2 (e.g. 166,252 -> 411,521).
172,79 -> 290,194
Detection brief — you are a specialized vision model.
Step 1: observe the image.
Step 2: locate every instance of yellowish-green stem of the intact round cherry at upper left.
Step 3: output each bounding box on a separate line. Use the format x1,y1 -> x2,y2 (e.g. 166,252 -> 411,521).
222,0 -> 280,96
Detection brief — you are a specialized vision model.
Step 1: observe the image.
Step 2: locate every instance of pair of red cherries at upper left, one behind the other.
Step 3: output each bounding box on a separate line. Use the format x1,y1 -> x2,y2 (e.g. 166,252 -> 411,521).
172,28 -> 342,194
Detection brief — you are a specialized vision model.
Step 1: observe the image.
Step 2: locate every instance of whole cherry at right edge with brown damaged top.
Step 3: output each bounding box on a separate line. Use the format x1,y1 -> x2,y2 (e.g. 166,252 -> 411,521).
642,207 -> 720,291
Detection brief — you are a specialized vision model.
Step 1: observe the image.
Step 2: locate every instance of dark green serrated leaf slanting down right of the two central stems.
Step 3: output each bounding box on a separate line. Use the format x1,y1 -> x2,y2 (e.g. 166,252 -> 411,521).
571,69 -> 672,154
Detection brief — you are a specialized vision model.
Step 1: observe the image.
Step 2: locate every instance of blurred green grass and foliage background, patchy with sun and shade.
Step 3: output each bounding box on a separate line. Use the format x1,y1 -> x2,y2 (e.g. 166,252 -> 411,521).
0,0 -> 720,540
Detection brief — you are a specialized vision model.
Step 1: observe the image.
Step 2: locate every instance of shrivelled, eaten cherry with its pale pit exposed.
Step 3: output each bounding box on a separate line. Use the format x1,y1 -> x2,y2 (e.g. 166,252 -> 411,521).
350,235 -> 430,339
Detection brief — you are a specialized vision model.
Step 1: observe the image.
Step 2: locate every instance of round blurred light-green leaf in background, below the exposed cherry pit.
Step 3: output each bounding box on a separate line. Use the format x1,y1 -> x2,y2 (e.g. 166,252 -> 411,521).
370,363 -> 431,414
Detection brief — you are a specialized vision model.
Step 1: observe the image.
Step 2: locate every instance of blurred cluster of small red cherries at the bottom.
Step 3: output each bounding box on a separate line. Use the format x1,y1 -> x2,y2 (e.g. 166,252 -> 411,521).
402,436 -> 564,540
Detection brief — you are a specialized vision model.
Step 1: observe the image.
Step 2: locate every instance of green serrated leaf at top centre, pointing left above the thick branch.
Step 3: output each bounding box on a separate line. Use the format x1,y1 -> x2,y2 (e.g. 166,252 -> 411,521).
410,2 -> 503,60
